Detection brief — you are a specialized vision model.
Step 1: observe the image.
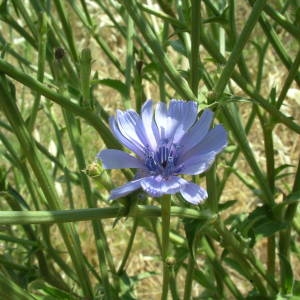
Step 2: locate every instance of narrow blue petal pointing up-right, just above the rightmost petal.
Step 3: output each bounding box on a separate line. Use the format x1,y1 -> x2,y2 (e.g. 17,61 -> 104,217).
179,109 -> 214,153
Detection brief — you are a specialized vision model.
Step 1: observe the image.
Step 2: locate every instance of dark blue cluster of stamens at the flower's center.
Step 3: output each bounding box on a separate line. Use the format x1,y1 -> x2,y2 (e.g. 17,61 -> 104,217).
145,142 -> 182,178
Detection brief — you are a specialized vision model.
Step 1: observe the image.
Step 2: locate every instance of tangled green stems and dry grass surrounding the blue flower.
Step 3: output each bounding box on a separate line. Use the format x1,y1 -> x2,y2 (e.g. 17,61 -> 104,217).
0,0 -> 300,299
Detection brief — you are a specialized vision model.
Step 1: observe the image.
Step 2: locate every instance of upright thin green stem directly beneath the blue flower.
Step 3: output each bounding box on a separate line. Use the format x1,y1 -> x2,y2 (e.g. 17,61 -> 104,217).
161,195 -> 171,300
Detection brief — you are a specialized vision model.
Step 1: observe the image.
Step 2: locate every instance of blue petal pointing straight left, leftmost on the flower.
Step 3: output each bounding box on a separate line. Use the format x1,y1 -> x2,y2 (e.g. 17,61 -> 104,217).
97,149 -> 144,169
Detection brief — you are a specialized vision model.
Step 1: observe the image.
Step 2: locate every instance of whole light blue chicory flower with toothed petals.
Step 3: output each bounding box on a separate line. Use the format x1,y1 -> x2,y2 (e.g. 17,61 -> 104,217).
97,100 -> 227,204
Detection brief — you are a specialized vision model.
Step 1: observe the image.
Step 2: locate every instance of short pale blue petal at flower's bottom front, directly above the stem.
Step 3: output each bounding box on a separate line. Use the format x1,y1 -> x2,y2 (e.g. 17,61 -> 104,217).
141,176 -> 185,197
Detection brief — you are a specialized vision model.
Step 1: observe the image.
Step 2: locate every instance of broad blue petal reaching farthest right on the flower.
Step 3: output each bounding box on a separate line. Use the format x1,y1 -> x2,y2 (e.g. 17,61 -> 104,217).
178,125 -> 227,163
